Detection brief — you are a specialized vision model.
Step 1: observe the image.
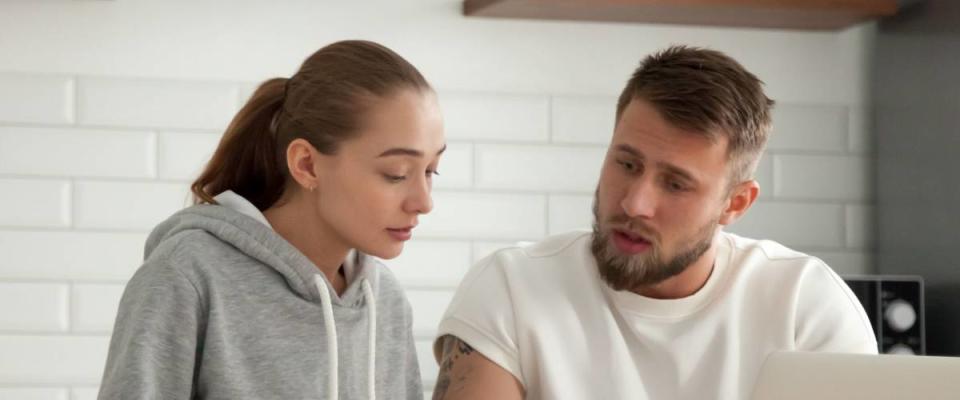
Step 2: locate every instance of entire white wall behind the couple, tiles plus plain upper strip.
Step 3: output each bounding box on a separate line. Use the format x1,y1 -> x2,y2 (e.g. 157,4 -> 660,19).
0,0 -> 873,394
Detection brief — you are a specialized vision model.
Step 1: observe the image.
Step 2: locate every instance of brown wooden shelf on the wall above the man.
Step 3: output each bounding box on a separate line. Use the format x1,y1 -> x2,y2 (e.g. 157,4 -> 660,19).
463,0 -> 897,30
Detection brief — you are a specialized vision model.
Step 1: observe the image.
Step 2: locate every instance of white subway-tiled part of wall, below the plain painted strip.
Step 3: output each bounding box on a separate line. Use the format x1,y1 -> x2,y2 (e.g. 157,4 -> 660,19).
0,32 -> 873,400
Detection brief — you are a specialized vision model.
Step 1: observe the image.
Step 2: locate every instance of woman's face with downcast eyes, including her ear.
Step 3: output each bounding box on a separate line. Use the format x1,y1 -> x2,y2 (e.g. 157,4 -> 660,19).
317,90 -> 446,259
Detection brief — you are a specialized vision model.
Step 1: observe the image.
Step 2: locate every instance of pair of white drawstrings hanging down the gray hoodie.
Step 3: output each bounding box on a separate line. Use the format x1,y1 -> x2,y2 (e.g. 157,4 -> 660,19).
314,275 -> 377,400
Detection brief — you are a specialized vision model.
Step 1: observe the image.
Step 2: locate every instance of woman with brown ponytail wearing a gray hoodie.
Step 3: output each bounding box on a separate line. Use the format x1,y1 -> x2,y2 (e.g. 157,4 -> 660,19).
99,41 -> 445,399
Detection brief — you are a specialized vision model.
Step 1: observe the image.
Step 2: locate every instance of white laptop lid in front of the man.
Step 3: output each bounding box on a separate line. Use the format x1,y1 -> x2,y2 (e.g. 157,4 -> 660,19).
752,352 -> 960,400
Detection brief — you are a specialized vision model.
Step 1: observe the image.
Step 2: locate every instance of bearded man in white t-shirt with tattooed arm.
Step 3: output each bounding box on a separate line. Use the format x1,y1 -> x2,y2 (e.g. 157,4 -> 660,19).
434,46 -> 877,400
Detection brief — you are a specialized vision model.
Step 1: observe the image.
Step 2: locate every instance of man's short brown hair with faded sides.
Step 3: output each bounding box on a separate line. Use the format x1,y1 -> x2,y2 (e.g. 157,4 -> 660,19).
617,46 -> 774,187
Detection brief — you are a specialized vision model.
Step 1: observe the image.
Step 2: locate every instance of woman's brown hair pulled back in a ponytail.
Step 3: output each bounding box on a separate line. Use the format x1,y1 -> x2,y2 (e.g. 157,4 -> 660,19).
190,40 -> 432,211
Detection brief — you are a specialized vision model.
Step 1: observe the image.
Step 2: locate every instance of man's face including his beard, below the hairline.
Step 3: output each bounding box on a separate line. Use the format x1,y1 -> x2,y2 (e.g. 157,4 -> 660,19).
591,99 -> 728,290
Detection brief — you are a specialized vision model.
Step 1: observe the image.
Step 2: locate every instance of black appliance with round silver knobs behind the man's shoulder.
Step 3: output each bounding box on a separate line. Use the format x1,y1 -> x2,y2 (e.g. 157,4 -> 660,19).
843,275 -> 927,355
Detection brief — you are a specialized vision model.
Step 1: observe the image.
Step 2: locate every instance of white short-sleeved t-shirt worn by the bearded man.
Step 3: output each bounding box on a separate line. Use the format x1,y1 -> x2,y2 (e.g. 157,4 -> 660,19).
434,232 -> 877,400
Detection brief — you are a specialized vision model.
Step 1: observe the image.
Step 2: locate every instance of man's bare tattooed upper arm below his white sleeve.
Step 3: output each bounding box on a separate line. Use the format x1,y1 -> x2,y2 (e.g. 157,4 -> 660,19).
433,335 -> 524,400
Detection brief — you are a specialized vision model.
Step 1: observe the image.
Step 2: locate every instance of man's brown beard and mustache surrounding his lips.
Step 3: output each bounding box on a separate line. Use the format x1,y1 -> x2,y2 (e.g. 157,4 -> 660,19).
590,195 -> 719,291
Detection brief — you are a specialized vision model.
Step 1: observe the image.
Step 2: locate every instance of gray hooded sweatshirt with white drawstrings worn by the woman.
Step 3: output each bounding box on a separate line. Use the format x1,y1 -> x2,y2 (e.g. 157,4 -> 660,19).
99,198 -> 423,400
